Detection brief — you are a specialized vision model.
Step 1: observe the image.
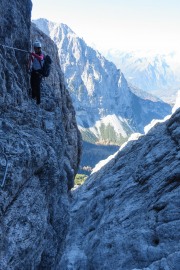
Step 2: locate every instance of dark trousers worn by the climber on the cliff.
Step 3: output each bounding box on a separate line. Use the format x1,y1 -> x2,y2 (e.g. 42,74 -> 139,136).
31,71 -> 42,104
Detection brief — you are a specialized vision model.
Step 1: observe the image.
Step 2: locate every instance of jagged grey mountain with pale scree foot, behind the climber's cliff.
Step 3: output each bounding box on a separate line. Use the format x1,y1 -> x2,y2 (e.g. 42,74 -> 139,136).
34,19 -> 171,145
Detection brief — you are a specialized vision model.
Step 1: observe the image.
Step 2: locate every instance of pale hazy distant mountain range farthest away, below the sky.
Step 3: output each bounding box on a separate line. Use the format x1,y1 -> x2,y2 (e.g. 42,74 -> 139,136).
104,49 -> 180,103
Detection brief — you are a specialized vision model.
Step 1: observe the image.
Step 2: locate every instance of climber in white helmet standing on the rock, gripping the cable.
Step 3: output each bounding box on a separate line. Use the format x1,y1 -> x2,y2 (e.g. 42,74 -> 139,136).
28,41 -> 44,104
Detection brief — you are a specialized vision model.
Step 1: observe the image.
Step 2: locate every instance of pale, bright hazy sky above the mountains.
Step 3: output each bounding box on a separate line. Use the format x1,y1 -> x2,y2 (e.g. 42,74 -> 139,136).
32,0 -> 180,51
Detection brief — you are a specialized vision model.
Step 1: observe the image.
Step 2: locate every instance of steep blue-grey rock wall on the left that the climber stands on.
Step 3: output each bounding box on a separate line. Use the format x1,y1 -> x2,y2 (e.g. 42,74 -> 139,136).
0,0 -> 81,269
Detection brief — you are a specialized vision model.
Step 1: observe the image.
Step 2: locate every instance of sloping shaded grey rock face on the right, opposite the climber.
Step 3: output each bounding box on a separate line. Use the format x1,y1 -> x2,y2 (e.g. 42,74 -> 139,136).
59,109 -> 180,270
